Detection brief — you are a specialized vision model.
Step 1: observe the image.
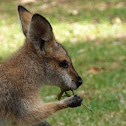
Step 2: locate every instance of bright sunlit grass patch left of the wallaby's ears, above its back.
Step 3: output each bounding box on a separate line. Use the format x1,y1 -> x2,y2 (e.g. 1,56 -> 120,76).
0,23 -> 24,60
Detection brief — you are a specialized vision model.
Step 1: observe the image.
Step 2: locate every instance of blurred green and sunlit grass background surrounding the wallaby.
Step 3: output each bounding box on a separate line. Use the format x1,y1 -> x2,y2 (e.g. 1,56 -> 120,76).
0,0 -> 126,126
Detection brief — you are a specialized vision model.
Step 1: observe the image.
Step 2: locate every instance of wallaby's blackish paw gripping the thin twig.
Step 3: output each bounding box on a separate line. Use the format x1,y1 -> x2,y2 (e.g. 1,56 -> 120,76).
63,95 -> 83,107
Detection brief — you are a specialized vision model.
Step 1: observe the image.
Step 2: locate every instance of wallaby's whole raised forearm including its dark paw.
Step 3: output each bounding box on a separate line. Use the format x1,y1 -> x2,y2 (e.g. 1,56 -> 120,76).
19,95 -> 83,126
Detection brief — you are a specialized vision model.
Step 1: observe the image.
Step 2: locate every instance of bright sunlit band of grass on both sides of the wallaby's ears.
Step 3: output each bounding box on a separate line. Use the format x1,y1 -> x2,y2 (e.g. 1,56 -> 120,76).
0,18 -> 126,61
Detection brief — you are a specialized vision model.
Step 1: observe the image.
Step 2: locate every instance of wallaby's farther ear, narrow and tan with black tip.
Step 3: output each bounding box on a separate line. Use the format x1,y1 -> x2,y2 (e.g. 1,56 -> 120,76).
18,6 -> 33,36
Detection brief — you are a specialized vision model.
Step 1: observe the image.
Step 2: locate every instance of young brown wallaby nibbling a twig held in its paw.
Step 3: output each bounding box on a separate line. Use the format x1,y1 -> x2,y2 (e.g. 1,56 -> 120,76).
0,6 -> 82,126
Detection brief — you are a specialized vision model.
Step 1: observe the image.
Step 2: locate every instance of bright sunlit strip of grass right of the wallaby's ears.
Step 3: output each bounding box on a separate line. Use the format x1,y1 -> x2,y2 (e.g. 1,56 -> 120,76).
53,23 -> 126,43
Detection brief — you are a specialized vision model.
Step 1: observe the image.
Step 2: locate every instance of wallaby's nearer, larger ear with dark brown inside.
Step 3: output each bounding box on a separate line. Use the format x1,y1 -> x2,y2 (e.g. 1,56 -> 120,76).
28,14 -> 54,53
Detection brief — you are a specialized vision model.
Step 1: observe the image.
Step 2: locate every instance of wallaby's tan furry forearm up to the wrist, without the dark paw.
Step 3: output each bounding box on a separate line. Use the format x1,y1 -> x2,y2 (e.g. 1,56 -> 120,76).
19,101 -> 68,126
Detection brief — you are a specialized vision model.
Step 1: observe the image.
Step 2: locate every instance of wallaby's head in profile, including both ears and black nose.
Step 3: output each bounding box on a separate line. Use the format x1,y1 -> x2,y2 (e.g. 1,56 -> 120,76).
18,6 -> 82,90
